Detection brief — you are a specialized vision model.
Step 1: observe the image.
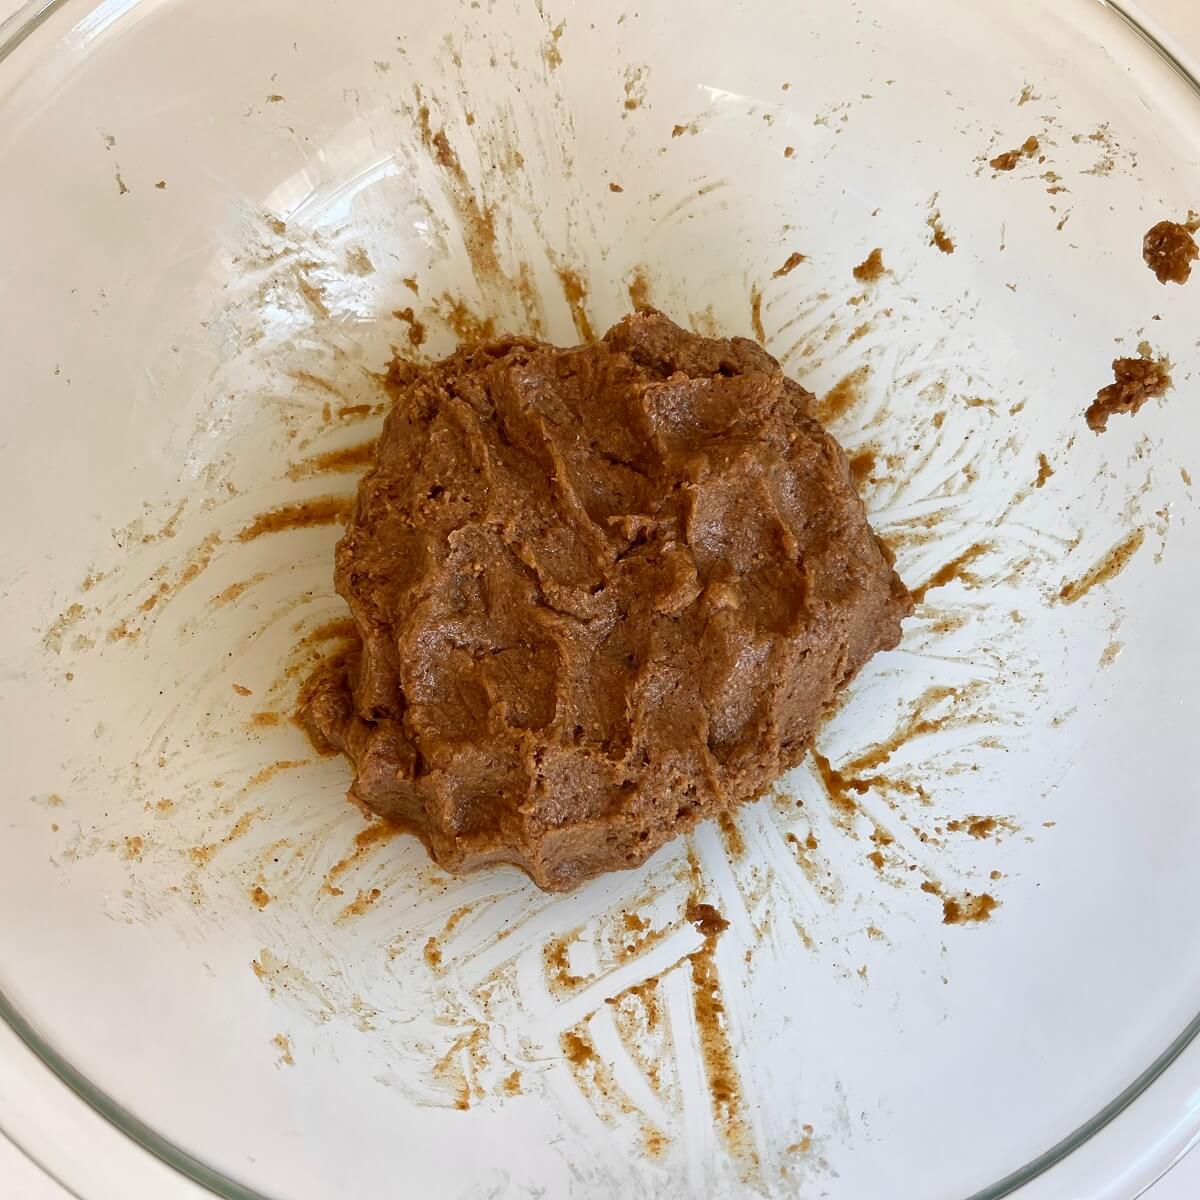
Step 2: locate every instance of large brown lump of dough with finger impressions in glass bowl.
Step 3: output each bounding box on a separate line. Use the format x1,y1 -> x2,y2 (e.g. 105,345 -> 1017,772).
306,310 -> 912,890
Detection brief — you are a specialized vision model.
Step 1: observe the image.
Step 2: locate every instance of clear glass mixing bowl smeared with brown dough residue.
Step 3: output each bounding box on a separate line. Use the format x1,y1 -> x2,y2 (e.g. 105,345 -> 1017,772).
0,0 -> 1200,1200
